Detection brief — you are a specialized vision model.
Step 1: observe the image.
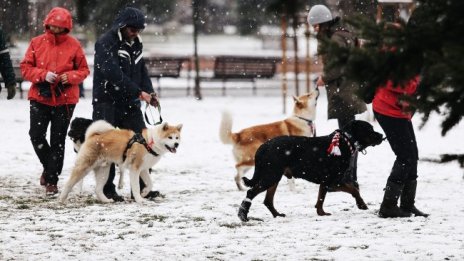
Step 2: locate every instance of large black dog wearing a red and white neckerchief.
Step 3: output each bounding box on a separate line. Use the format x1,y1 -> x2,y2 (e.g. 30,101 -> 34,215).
238,121 -> 383,221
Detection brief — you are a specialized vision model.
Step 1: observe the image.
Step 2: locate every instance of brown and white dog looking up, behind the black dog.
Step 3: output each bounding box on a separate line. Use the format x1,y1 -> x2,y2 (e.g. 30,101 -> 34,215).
219,90 -> 319,190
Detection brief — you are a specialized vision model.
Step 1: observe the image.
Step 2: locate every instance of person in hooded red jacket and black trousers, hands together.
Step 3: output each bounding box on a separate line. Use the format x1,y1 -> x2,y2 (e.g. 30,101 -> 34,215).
20,7 -> 90,195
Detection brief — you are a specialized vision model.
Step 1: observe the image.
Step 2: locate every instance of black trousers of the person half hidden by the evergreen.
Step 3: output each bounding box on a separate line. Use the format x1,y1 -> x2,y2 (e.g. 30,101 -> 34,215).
374,112 -> 419,184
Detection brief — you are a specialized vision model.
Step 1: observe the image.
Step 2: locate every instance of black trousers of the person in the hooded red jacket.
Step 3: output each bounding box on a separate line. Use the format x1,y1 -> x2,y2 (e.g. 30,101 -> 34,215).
29,101 -> 76,185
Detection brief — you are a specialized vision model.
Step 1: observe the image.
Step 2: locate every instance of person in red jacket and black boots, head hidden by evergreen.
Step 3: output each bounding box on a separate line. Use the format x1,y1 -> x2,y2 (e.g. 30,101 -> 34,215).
372,77 -> 428,218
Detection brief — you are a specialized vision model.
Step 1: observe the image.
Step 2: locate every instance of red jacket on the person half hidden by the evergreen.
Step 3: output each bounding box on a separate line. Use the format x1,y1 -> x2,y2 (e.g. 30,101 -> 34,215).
372,76 -> 419,120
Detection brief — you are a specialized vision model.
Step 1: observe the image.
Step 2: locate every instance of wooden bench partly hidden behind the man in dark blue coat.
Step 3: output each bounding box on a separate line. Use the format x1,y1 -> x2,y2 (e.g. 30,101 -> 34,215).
145,56 -> 190,96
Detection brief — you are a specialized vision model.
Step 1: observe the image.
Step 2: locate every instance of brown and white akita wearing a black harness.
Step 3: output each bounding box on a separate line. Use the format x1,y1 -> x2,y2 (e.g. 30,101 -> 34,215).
60,120 -> 182,203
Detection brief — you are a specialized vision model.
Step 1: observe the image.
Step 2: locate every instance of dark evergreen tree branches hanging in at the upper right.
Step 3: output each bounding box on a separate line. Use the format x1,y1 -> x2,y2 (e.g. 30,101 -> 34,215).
323,0 -> 464,165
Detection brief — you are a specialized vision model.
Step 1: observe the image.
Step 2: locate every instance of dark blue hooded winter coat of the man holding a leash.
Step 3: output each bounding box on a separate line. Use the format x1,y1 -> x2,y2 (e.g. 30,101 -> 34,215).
92,7 -> 154,106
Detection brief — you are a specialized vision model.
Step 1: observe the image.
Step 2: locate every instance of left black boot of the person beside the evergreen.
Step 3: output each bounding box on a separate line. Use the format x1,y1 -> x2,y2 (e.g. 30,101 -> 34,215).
379,181 -> 411,218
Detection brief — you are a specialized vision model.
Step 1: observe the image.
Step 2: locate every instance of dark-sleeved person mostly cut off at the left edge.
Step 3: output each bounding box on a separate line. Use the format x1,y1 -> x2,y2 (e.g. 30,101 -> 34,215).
0,28 -> 16,100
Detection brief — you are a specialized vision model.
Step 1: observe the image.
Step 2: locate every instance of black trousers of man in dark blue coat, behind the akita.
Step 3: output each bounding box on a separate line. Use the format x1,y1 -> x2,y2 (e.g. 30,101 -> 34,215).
92,103 -> 146,195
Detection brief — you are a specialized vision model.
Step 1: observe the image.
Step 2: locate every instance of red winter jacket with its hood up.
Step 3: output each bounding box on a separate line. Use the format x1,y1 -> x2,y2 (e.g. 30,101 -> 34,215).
20,7 -> 90,106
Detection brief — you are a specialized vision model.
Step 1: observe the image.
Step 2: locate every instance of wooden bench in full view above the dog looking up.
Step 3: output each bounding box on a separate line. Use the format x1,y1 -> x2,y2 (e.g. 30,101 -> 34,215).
206,55 -> 281,95
